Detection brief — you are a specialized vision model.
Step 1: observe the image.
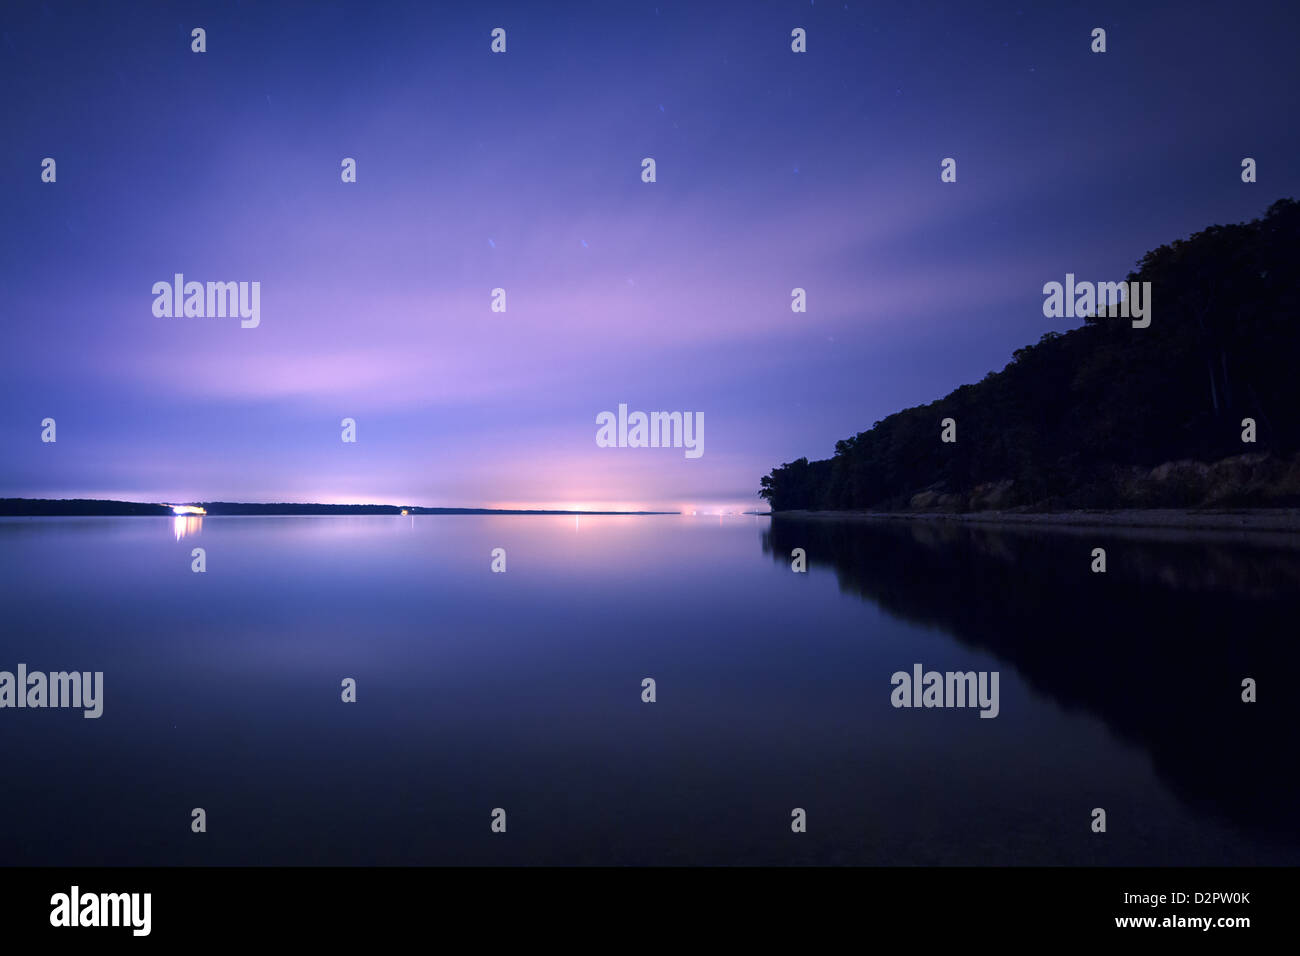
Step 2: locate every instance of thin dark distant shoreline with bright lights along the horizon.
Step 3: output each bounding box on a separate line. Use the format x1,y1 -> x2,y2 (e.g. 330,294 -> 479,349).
0,498 -> 681,518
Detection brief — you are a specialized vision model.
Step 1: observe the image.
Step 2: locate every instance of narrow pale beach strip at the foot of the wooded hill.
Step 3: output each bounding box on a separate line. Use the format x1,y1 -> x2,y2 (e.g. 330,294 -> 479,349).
772,509 -> 1300,533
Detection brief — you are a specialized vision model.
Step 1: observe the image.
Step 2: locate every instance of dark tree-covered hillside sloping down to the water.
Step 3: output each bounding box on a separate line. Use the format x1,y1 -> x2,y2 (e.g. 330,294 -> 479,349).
759,199 -> 1300,520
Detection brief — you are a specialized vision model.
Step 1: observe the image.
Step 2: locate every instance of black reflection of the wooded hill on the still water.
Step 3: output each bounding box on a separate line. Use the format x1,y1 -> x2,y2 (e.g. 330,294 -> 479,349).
762,516 -> 1300,844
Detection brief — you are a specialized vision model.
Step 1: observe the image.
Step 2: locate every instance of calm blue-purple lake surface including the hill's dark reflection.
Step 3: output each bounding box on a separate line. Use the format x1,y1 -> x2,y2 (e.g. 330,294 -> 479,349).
0,516 -> 1300,863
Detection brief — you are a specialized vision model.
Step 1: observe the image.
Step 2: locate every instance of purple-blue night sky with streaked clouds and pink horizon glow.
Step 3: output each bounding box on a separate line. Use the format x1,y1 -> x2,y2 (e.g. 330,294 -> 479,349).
0,0 -> 1300,510
